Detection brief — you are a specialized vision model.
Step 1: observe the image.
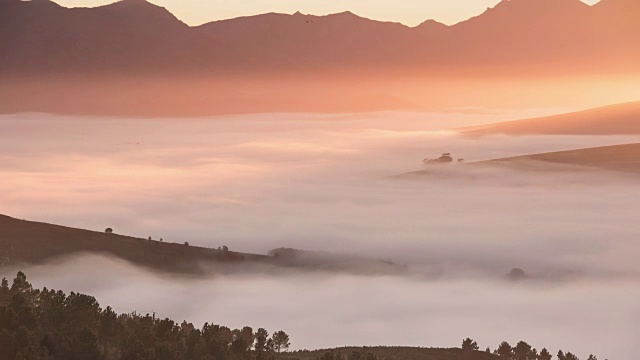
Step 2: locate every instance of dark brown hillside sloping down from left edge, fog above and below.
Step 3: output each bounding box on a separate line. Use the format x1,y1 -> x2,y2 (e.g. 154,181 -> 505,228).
0,215 -> 406,275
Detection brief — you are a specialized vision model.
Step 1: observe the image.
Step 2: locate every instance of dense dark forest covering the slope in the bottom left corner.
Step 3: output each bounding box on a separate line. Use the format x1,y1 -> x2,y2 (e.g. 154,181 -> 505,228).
0,272 -> 290,360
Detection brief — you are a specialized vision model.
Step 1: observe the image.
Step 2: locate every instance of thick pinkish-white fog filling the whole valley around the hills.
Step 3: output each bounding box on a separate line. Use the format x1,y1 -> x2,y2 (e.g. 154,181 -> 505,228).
0,109 -> 640,360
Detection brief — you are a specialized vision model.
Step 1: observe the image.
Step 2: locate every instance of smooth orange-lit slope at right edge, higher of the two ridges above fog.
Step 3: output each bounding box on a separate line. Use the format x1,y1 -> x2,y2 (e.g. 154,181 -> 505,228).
458,101 -> 640,136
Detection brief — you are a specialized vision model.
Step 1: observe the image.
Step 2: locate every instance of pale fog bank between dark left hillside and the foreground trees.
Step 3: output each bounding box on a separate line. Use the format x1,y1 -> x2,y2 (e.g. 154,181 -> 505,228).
1,256 -> 640,359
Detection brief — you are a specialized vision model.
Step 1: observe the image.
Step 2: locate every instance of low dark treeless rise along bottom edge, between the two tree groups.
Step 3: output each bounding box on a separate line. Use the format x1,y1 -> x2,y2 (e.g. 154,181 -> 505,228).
278,346 -> 498,360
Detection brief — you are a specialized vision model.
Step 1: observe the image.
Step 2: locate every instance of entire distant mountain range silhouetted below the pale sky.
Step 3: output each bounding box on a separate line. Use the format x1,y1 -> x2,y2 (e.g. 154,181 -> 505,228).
0,0 -> 640,76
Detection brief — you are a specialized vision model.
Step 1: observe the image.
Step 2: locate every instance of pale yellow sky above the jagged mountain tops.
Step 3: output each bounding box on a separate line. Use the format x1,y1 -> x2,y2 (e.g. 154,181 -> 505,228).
56,0 -> 598,26
